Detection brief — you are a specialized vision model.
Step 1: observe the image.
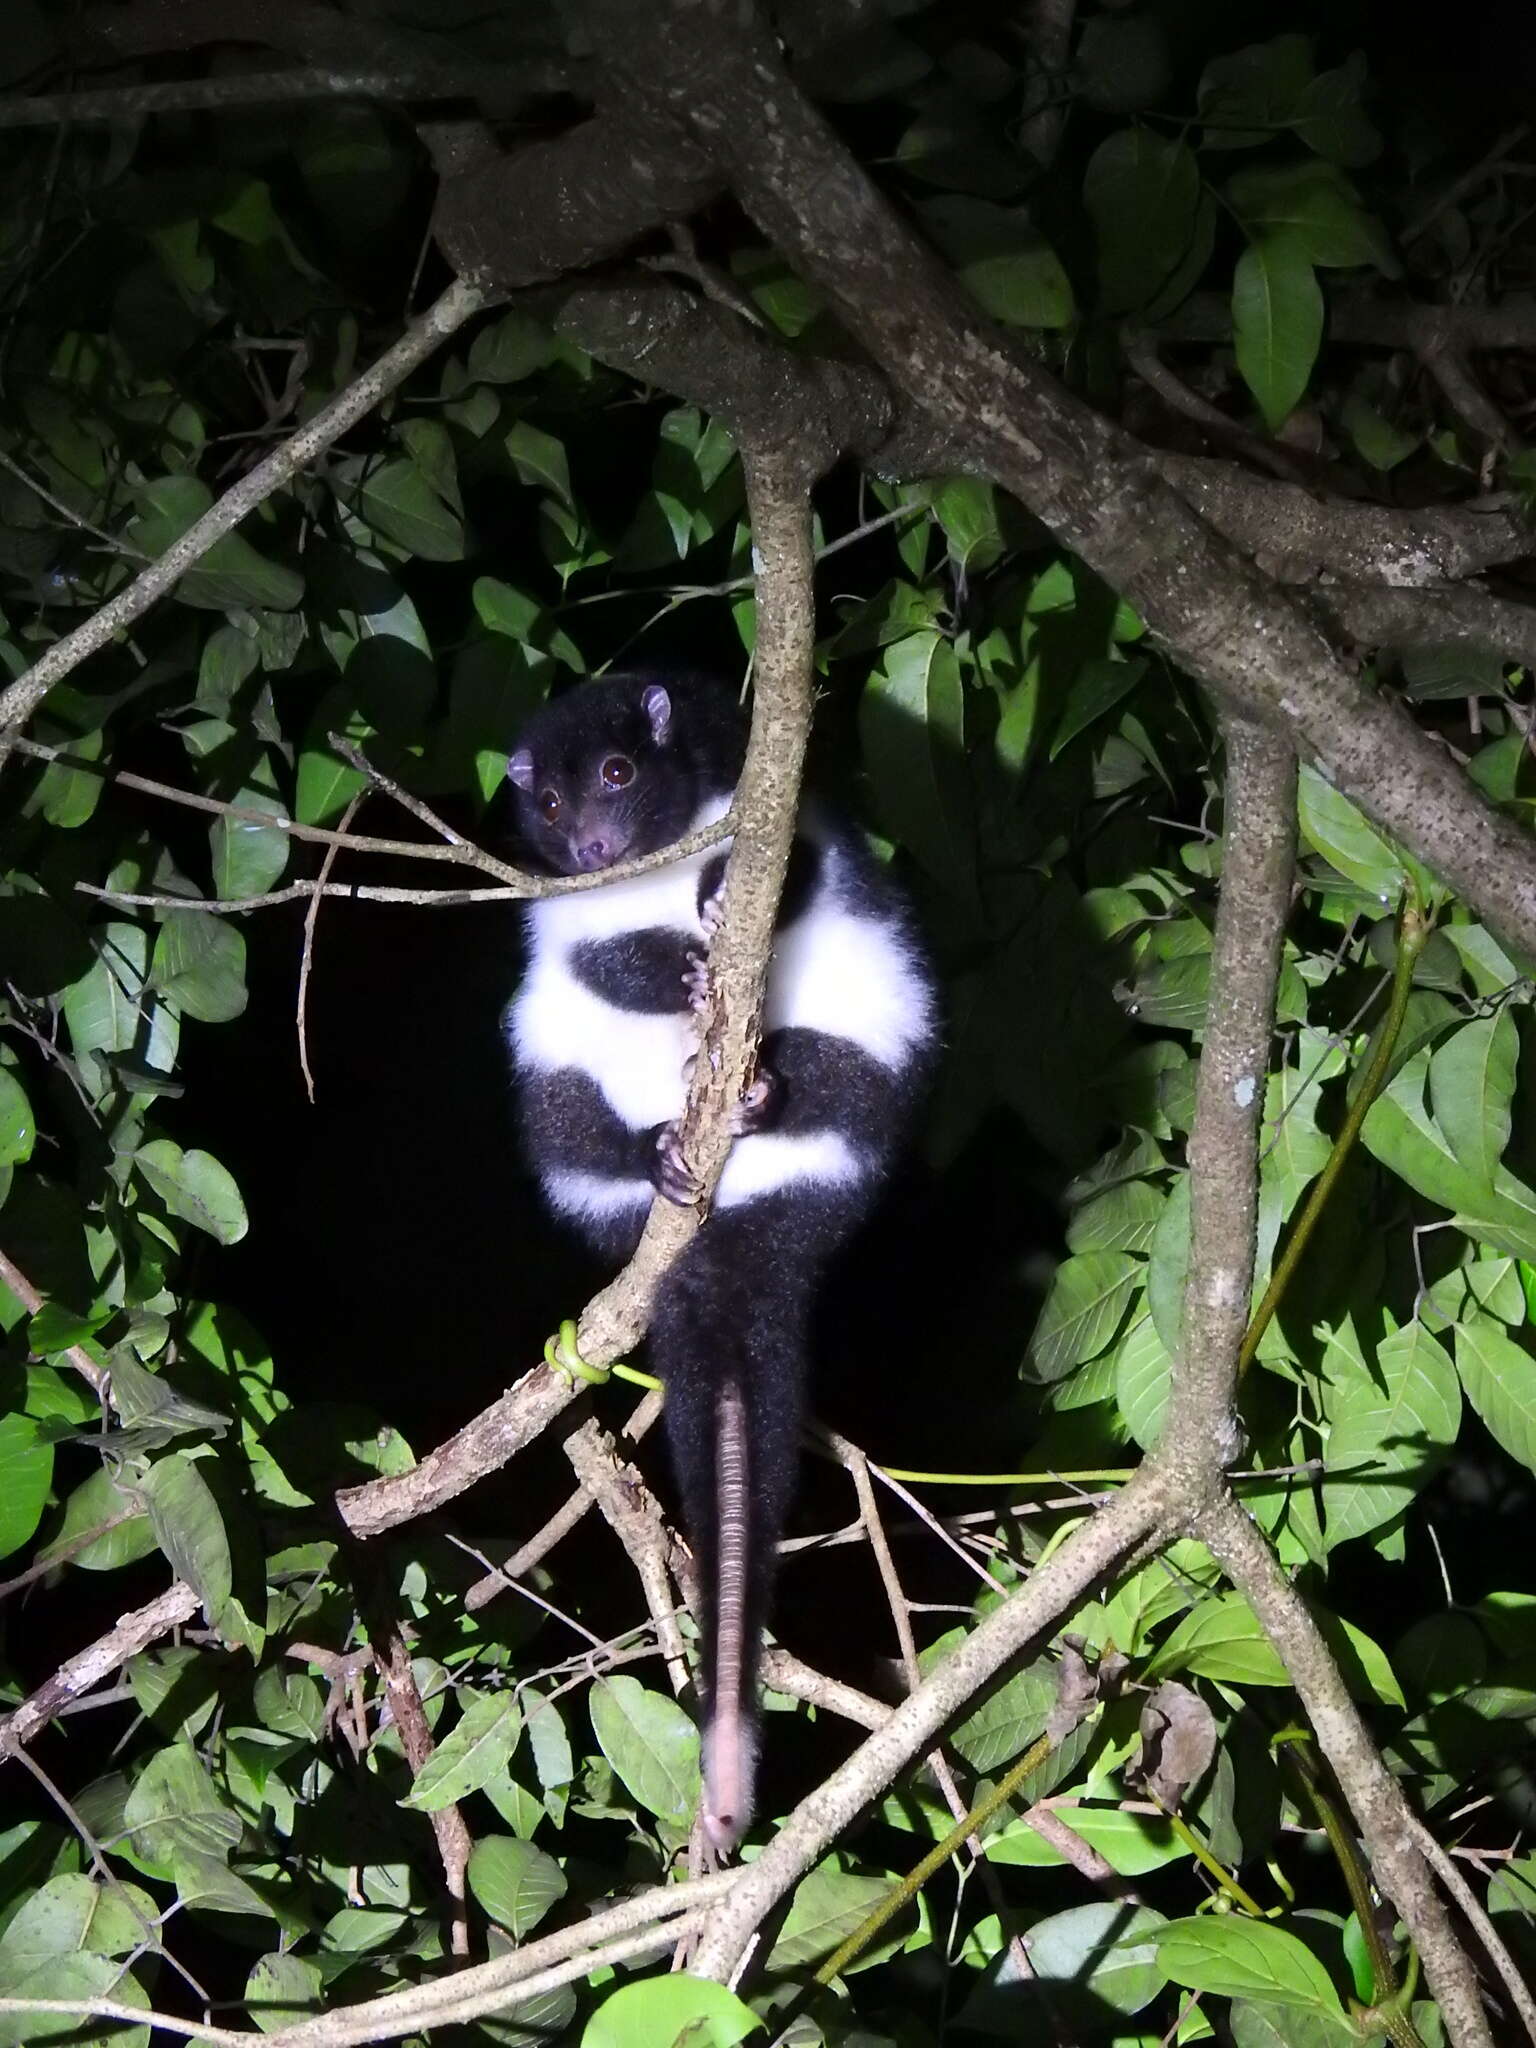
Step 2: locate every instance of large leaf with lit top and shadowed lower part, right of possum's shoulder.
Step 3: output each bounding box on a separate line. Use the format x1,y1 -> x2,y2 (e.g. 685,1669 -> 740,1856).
858,633 -> 975,897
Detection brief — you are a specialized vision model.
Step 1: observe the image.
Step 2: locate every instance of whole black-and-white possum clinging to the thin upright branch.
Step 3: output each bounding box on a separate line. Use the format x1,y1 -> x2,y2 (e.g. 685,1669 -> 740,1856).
506,676 -> 934,1851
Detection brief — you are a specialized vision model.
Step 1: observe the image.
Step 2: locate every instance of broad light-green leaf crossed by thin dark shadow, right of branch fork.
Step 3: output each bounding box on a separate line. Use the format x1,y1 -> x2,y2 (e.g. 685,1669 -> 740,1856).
1323,1323 -> 1462,1550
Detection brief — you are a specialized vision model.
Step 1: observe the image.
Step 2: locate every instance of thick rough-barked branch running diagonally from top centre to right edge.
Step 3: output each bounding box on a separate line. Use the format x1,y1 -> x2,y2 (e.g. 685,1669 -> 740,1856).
594,0 -> 1536,958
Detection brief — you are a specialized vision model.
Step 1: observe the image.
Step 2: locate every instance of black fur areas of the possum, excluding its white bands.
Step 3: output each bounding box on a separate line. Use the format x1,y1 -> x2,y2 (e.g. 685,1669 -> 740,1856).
510,676 -> 932,1839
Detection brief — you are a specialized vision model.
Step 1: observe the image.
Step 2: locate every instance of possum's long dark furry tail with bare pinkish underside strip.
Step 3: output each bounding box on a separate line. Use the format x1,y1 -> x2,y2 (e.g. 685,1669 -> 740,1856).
651,1198 -> 825,1853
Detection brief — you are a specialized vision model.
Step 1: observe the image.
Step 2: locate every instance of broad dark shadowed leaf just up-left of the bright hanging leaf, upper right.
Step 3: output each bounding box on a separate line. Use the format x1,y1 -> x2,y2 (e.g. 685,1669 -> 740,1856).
1083,127 -> 1200,313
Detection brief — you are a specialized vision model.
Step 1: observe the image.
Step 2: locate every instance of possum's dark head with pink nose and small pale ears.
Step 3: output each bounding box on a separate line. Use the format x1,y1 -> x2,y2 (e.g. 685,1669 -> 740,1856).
506,676 -> 739,874
